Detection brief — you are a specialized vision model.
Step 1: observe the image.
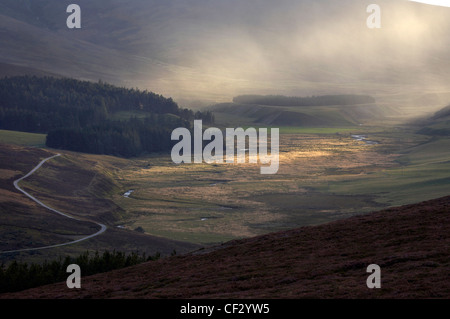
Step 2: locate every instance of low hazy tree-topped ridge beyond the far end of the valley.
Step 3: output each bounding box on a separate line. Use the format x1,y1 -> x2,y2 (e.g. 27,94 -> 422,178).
208,95 -> 399,127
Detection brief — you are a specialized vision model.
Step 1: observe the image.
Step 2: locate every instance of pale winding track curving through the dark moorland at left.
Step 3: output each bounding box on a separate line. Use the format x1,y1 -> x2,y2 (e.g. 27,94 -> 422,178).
0,154 -> 107,254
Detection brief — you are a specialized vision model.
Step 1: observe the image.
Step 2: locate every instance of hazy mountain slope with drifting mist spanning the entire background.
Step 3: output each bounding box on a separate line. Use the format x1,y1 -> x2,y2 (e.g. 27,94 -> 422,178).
0,0 -> 449,104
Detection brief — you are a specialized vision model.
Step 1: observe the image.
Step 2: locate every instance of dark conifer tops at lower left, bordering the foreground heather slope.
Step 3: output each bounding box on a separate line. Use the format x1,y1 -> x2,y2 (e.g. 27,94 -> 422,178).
0,250 -> 161,293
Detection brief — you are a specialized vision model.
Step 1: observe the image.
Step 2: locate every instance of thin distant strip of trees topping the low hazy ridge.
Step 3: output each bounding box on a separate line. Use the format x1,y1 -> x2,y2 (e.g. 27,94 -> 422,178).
233,94 -> 375,106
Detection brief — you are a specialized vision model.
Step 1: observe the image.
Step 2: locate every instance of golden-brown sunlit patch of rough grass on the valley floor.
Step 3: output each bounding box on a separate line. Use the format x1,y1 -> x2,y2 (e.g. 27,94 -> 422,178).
111,134 -> 395,244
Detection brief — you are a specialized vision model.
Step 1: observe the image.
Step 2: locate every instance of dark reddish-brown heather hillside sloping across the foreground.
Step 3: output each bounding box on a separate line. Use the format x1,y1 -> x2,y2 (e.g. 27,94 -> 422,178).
1,196 -> 450,299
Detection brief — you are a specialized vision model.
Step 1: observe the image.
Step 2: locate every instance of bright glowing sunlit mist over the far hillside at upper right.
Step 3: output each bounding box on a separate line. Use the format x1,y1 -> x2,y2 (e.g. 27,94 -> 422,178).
144,0 -> 450,103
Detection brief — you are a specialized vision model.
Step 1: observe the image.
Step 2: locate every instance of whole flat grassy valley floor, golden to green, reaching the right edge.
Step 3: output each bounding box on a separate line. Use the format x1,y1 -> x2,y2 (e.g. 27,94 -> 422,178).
107,122 -> 450,244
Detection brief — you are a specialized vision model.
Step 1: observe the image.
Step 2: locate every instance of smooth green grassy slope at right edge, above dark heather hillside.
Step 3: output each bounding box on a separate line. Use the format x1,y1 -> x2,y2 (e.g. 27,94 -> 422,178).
328,137 -> 450,206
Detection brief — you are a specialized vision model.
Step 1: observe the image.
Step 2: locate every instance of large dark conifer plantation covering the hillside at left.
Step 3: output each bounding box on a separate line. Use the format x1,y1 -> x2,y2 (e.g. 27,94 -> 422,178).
0,76 -> 214,157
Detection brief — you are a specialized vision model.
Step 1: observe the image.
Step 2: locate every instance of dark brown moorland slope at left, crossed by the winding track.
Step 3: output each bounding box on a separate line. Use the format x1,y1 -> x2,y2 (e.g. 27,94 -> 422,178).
0,143 -> 198,263
